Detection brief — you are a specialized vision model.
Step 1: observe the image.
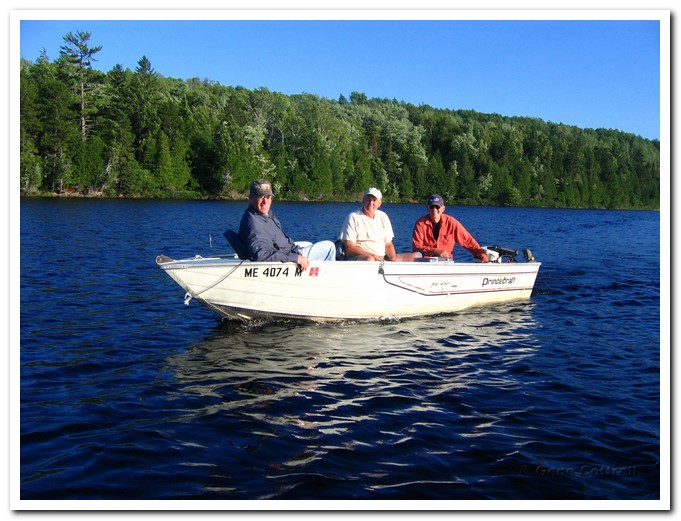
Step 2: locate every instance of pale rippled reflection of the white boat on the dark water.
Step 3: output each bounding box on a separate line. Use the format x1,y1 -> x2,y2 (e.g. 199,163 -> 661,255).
163,303 -> 538,432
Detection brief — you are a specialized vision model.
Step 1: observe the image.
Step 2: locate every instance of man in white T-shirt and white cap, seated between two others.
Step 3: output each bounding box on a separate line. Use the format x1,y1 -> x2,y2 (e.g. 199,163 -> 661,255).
340,188 -> 421,261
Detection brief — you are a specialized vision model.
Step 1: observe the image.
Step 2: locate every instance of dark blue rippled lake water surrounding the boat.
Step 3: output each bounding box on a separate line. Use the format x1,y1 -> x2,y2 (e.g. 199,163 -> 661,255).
15,199 -> 661,500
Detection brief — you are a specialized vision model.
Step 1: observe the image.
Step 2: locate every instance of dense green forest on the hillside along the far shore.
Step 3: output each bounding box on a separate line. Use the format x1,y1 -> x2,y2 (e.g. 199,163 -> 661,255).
20,32 -> 660,209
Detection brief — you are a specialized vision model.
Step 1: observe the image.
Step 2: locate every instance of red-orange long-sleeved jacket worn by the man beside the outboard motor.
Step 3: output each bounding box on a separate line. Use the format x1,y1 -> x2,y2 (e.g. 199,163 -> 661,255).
412,214 -> 485,257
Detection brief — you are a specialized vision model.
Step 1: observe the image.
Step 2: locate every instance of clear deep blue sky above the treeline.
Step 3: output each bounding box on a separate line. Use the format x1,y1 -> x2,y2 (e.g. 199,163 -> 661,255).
20,11 -> 669,139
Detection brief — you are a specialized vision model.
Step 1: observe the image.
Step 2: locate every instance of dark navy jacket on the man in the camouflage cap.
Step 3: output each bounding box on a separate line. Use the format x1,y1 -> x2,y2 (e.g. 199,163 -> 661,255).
239,205 -> 301,262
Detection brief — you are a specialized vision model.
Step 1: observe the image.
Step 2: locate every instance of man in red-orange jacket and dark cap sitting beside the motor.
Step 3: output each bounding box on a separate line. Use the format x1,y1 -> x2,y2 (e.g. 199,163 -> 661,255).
412,195 -> 489,262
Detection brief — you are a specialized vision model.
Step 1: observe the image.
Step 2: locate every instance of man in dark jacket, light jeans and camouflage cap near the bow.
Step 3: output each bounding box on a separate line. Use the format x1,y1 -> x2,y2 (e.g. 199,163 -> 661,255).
239,179 -> 336,271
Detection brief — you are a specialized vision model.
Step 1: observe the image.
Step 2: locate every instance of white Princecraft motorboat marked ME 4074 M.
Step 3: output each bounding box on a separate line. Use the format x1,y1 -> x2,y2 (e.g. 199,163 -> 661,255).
156,240 -> 541,322
